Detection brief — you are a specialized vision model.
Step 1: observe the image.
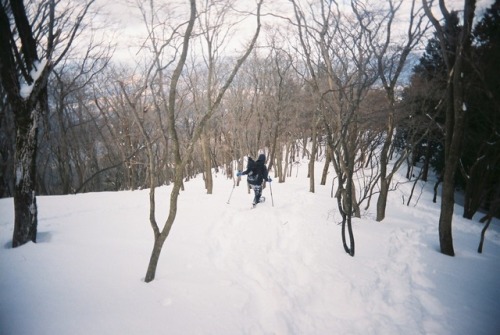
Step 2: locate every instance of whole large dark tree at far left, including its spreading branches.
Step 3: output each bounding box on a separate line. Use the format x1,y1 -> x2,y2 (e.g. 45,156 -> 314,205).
0,0 -> 94,247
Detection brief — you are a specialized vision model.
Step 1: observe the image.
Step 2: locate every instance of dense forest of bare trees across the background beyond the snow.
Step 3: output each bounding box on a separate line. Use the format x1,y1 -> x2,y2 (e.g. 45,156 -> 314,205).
0,0 -> 500,281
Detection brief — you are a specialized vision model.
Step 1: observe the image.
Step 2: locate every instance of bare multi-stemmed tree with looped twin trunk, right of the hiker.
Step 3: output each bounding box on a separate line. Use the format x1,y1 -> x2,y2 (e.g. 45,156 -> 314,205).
292,1 -> 376,256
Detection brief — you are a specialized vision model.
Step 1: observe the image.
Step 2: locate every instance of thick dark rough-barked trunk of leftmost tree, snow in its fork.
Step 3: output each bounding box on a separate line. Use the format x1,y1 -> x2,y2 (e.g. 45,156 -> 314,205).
0,1 -> 50,247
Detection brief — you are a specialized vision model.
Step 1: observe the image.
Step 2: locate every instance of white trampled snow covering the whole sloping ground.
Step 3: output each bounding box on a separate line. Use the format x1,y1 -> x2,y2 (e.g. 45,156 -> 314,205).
0,162 -> 500,335
